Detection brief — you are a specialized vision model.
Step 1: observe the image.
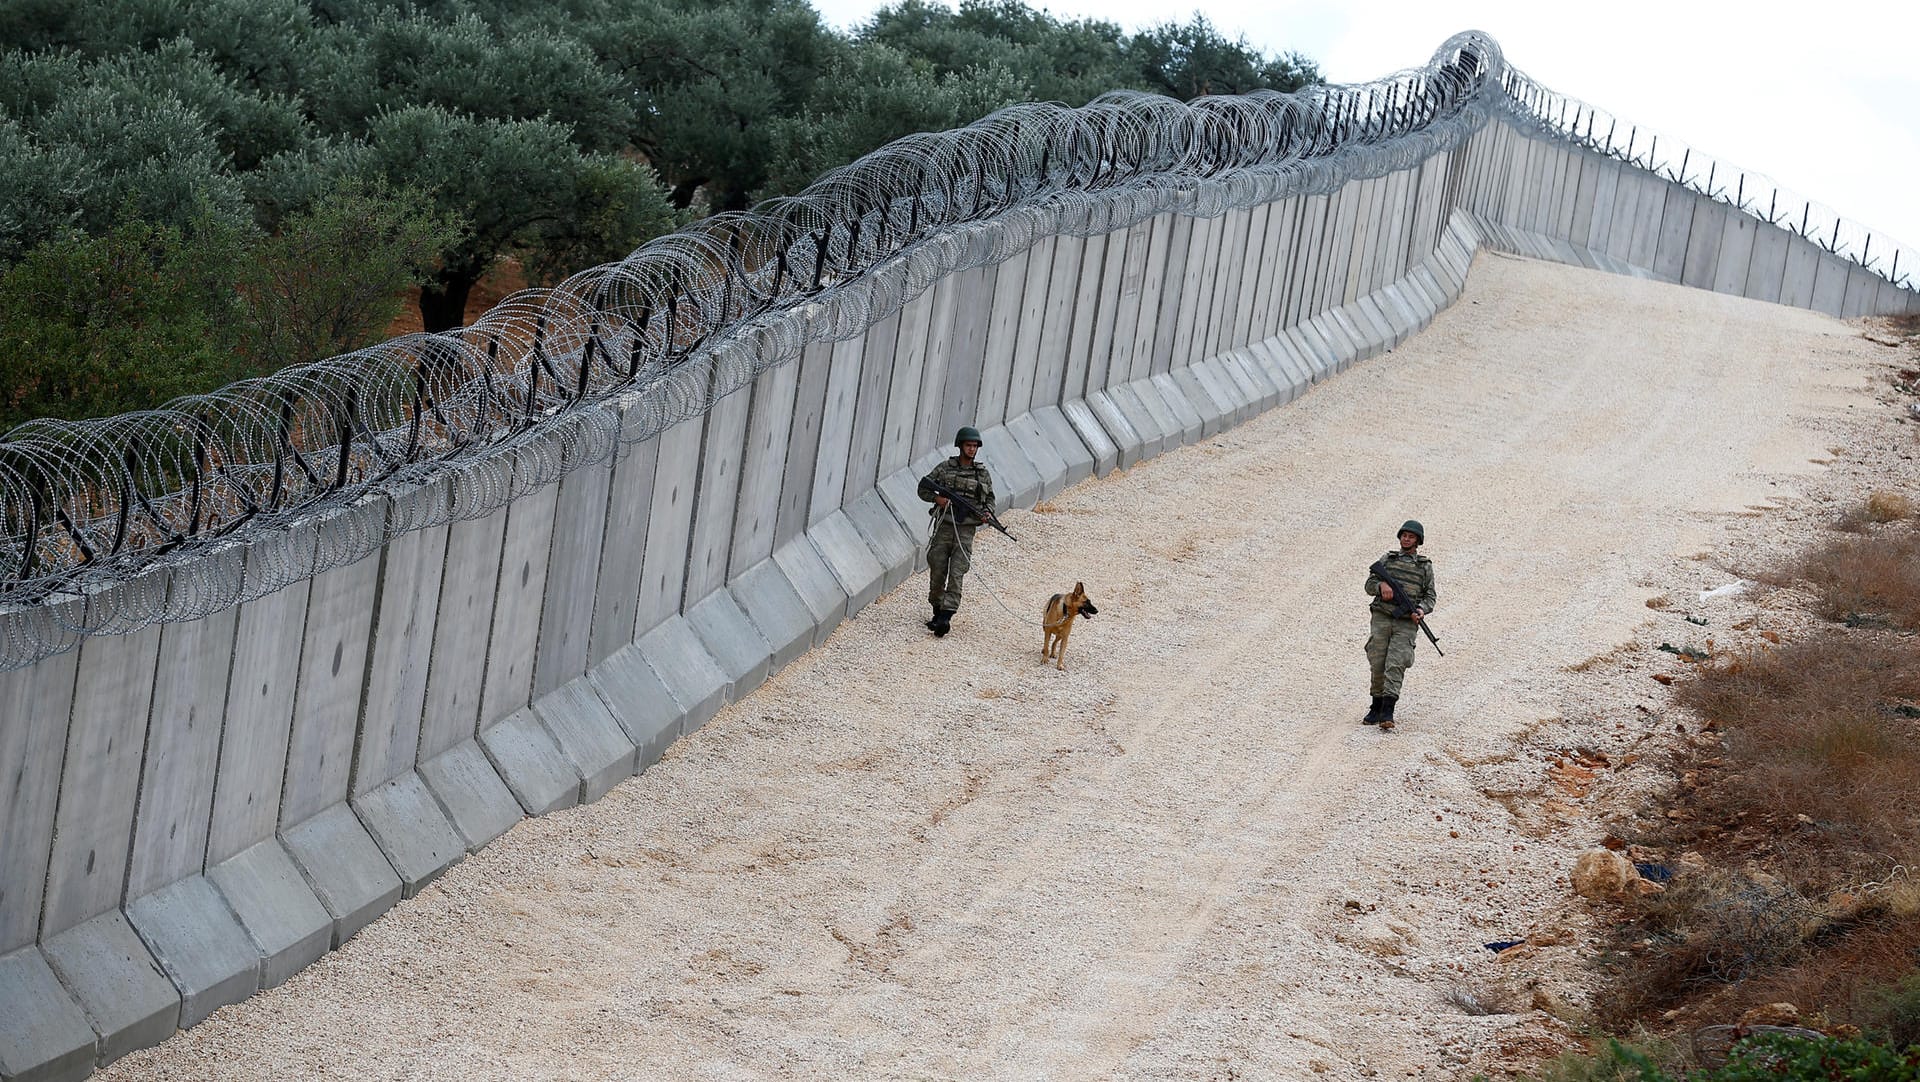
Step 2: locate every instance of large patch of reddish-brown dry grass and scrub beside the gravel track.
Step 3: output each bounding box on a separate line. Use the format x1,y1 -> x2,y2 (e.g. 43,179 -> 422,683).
1596,517 -> 1920,1032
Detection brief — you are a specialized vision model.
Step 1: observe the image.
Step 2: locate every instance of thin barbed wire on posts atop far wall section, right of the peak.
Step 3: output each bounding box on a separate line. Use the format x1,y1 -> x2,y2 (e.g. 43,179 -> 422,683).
1500,65 -> 1920,290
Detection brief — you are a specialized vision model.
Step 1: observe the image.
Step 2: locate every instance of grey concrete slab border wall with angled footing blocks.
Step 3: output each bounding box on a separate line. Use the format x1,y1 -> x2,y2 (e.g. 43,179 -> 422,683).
0,105 -> 1920,1080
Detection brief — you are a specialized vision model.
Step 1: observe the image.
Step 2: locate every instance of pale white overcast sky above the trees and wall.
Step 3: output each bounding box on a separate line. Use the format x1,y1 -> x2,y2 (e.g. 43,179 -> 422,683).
814,0 -> 1920,271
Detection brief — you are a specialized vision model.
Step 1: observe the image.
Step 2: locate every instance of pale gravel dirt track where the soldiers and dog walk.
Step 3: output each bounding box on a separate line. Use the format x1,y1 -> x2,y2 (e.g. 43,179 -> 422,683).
102,253 -> 1884,1080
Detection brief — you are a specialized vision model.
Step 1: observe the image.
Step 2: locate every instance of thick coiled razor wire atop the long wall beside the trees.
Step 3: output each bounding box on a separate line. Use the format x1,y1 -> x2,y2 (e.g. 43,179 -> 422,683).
0,31 -> 1904,670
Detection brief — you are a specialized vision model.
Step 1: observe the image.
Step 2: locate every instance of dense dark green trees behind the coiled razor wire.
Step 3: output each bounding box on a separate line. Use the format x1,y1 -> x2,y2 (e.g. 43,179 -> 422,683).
0,0 -> 1317,428
